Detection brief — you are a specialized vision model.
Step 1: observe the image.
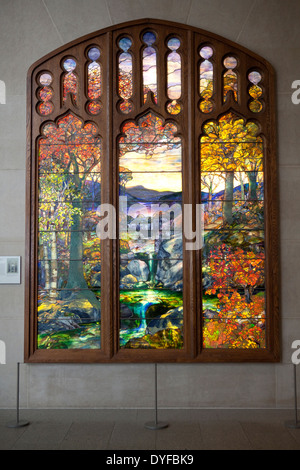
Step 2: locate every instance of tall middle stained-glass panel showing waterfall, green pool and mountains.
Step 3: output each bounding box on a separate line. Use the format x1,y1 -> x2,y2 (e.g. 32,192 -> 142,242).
119,113 -> 183,349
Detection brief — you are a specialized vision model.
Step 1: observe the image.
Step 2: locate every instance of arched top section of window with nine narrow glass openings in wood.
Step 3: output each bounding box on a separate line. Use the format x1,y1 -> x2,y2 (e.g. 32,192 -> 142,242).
28,19 -> 274,123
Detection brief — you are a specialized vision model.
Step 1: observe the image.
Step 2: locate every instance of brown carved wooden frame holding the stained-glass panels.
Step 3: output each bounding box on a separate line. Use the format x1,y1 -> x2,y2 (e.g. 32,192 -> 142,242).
24,19 -> 280,363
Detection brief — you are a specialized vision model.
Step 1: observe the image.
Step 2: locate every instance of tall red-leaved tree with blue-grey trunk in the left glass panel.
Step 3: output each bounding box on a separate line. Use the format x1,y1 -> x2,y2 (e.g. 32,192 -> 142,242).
39,114 -> 101,309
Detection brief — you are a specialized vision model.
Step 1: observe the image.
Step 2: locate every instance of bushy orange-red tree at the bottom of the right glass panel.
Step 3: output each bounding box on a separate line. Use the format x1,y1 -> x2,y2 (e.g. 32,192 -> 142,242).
205,245 -> 265,347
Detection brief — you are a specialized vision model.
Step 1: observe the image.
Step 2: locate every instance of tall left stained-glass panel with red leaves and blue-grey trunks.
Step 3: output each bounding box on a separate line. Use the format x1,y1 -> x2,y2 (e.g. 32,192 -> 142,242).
38,114 -> 101,349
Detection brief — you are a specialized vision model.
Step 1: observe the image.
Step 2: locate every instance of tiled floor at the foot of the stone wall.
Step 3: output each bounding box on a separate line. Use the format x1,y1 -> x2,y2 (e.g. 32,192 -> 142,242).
0,409 -> 300,450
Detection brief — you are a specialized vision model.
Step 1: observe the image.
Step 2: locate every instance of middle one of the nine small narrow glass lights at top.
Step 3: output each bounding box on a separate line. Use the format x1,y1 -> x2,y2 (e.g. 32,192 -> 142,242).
143,31 -> 157,103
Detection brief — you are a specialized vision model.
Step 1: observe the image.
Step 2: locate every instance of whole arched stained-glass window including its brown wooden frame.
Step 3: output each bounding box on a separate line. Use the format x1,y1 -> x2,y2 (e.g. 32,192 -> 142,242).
25,19 -> 279,362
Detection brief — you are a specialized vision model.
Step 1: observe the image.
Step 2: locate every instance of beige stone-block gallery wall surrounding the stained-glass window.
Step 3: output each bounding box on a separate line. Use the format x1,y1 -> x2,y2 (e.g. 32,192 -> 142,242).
0,0 -> 300,408
